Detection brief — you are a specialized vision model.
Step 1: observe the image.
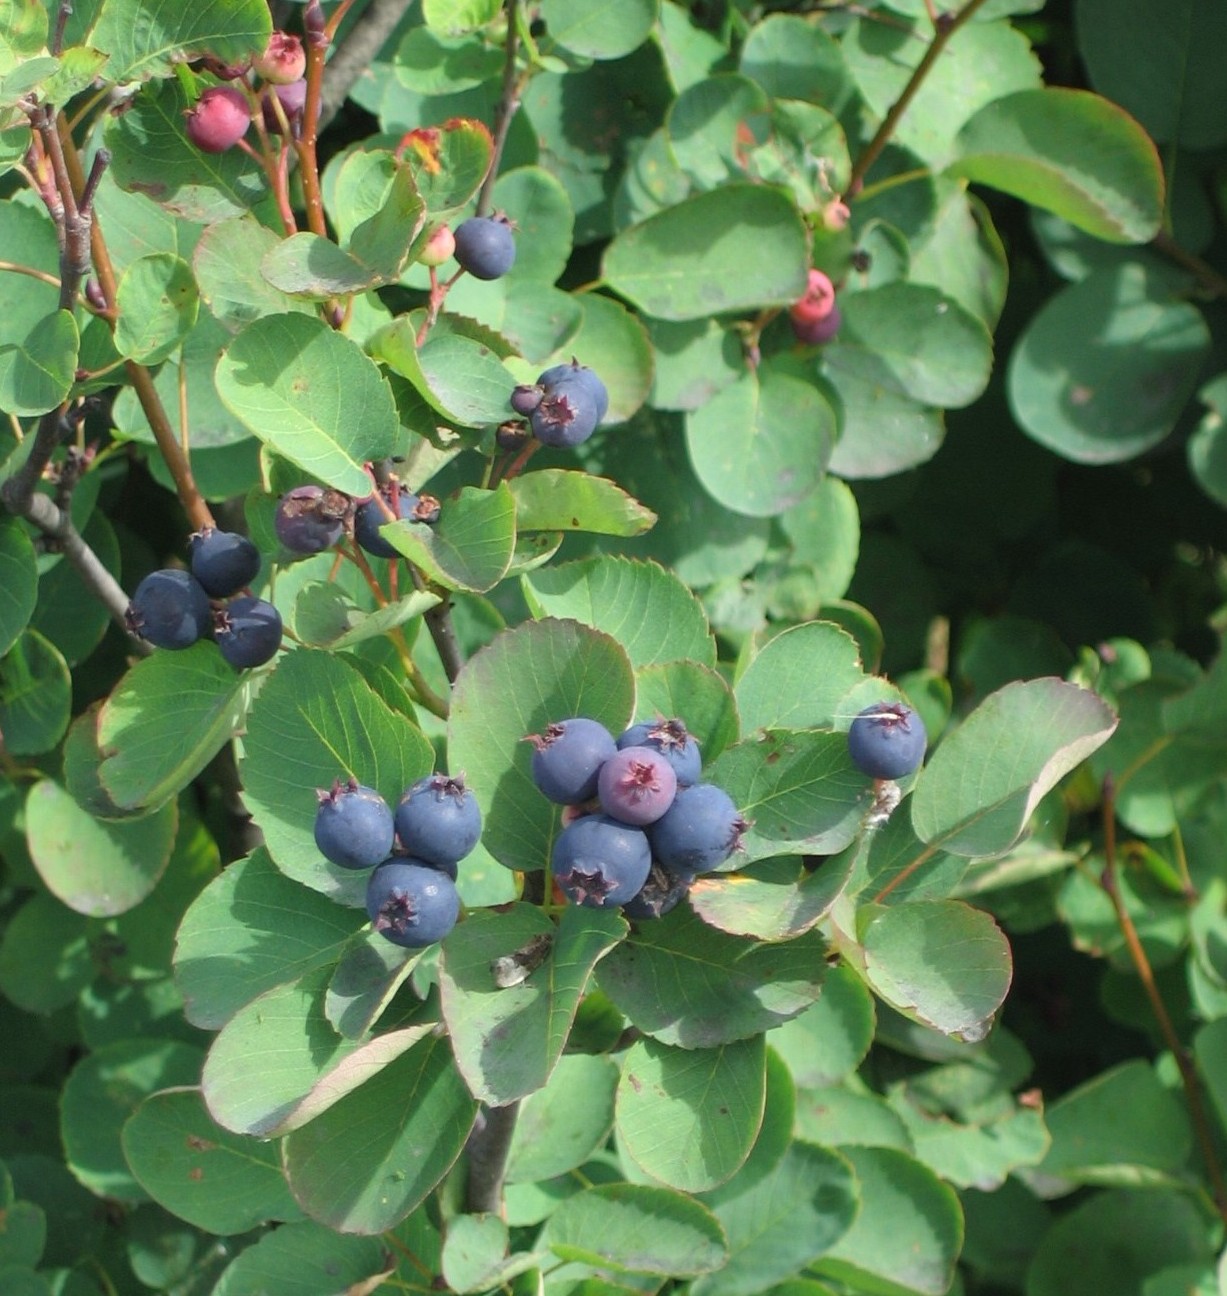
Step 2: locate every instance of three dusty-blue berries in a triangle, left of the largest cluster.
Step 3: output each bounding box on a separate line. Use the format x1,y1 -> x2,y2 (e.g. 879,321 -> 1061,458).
315,774 -> 482,950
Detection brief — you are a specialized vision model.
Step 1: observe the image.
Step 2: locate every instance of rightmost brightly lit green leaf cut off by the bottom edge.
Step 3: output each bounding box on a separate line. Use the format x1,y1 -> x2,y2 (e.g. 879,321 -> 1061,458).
816,1147 -> 969,1296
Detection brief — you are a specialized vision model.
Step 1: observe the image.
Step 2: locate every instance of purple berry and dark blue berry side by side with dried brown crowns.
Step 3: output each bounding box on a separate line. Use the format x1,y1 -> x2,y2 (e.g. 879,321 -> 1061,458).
273,481 -> 439,559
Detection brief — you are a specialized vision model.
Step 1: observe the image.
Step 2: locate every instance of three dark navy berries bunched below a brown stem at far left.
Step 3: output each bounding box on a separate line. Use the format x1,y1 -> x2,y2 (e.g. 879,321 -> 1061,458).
126,526 -> 281,670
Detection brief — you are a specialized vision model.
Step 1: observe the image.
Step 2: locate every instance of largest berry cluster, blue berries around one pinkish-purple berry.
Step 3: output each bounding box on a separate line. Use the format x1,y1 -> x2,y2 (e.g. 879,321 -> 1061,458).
527,715 -> 748,919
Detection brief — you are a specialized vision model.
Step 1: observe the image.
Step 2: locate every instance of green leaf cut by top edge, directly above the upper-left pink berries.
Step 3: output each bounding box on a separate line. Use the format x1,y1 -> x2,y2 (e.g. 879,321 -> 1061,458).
91,0 -> 272,82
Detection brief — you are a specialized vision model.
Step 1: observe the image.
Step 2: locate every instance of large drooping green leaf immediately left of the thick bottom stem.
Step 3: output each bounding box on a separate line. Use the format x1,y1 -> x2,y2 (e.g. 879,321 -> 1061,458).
284,1031 -> 477,1234
